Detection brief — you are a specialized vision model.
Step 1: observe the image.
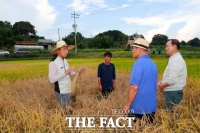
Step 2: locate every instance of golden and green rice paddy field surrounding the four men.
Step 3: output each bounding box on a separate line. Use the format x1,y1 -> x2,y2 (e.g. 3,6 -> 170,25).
0,58 -> 200,133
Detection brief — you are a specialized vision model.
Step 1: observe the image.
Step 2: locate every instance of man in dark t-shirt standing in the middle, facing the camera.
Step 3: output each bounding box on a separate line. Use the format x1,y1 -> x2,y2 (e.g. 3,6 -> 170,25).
97,52 -> 116,98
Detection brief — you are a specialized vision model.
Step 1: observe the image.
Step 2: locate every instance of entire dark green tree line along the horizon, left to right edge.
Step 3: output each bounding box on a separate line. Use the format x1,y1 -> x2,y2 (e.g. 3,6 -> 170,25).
0,21 -> 200,49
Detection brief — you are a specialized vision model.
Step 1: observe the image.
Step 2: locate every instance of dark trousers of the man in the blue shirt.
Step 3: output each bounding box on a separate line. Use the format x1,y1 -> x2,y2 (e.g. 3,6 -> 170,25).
128,112 -> 155,124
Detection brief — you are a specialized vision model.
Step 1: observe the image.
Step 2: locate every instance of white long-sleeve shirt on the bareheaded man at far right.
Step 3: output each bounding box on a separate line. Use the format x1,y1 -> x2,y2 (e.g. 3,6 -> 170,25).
162,52 -> 187,91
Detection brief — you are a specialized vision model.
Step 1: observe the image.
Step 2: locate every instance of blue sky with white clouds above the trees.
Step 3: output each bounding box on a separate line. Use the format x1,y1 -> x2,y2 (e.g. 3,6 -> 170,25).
0,0 -> 200,42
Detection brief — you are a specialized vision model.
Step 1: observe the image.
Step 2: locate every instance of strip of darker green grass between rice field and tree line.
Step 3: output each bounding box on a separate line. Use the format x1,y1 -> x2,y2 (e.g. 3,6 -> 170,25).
0,46 -> 200,61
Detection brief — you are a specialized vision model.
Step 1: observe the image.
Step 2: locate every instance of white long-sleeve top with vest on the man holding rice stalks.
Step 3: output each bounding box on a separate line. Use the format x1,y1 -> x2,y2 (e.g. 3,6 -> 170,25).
49,56 -> 76,94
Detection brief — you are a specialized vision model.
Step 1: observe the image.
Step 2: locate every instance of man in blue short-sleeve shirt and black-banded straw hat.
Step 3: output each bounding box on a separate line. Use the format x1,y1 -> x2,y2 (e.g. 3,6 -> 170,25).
124,38 -> 157,123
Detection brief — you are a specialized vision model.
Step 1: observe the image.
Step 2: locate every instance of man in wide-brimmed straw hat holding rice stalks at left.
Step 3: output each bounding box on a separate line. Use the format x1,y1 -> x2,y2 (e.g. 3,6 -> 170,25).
49,41 -> 79,109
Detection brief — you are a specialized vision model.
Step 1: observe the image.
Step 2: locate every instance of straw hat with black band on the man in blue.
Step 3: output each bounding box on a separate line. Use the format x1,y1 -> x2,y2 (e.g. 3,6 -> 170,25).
132,38 -> 149,50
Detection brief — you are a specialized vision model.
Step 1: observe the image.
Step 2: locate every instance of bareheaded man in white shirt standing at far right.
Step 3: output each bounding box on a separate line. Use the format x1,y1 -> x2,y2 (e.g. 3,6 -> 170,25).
158,39 -> 187,110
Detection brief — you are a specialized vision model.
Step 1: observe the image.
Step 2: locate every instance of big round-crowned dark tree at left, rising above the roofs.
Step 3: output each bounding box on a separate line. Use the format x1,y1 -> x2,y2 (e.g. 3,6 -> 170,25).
13,21 -> 36,37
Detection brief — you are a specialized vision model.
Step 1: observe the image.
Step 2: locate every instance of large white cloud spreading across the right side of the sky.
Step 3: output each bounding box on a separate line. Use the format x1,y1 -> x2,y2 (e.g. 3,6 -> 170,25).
121,0 -> 200,41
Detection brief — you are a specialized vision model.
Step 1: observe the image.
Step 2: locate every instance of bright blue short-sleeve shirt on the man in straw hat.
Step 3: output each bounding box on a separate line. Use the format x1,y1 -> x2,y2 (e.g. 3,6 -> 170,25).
130,55 -> 158,114
